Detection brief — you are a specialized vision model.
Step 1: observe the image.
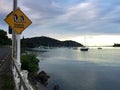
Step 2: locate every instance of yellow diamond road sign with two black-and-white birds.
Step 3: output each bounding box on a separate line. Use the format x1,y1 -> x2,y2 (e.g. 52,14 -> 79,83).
5,8 -> 32,34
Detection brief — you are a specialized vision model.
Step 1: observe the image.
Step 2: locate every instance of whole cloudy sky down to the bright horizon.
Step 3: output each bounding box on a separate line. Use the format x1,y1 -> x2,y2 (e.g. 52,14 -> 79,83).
0,0 -> 120,46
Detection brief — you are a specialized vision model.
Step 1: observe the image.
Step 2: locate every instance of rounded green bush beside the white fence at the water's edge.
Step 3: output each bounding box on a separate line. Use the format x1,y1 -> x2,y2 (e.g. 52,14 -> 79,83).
21,54 -> 39,75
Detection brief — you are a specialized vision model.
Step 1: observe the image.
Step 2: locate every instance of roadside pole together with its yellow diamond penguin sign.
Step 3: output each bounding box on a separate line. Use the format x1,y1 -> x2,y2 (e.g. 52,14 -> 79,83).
4,0 -> 32,66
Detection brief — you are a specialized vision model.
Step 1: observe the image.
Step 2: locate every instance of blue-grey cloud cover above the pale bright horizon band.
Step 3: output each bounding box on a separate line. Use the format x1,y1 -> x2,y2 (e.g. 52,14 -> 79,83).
0,0 -> 120,35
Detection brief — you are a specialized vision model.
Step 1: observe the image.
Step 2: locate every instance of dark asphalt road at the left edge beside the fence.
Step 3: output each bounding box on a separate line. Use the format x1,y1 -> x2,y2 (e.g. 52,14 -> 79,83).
0,46 -> 11,90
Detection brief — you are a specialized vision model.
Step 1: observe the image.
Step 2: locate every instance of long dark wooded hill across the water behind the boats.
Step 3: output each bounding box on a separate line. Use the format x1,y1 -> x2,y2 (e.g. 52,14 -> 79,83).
21,36 -> 83,48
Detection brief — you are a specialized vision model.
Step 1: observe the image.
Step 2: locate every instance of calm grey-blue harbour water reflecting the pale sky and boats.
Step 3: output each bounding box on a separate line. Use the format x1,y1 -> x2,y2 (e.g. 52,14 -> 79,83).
37,48 -> 120,90
